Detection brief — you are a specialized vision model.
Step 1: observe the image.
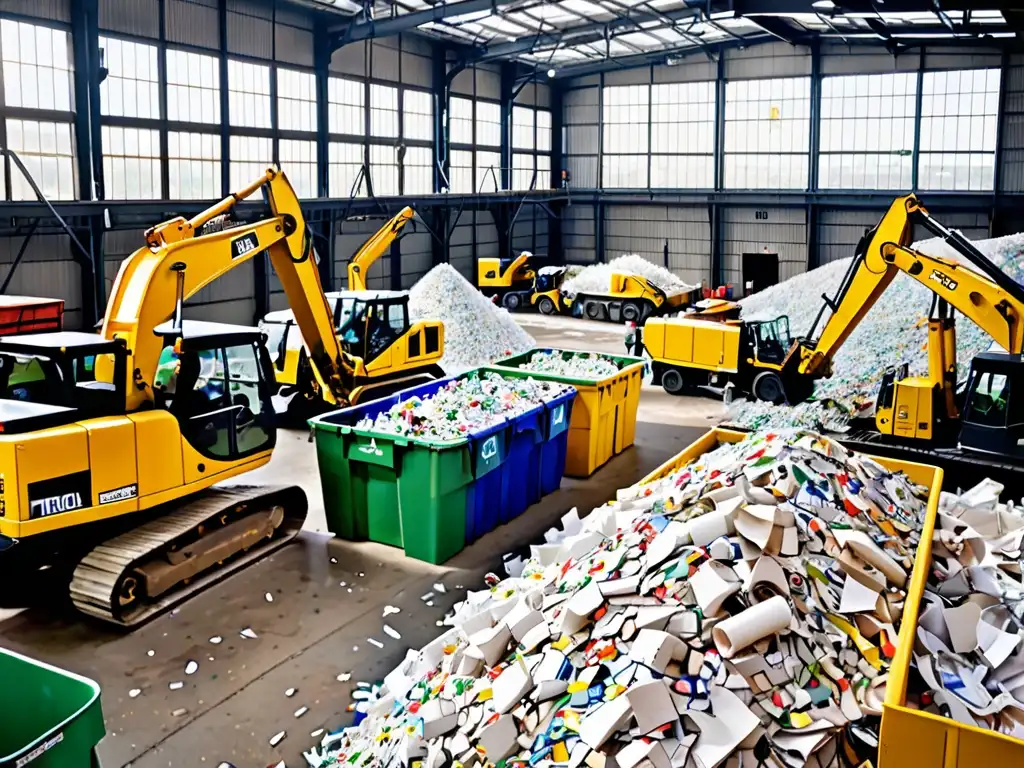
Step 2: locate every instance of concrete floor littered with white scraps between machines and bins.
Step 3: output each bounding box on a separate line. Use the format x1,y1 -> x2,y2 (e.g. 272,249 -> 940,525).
0,315 -> 722,768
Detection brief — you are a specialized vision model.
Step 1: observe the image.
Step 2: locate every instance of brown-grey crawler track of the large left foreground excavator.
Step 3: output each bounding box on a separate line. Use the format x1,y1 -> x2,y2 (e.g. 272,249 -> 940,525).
70,485 -> 307,628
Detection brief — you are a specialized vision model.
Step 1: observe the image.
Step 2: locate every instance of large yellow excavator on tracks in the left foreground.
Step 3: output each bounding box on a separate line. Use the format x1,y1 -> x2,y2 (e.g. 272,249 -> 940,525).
0,169 -> 432,627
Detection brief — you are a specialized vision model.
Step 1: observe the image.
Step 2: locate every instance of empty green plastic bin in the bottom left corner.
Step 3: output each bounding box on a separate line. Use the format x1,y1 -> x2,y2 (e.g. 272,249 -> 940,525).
0,648 -> 106,768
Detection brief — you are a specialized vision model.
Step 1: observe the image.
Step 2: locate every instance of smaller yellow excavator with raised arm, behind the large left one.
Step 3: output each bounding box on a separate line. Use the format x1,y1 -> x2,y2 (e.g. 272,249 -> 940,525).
259,206 -> 444,417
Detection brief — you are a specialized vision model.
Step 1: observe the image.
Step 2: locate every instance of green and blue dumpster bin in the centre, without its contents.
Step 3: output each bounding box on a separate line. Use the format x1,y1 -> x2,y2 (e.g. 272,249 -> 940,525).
309,370 -> 574,564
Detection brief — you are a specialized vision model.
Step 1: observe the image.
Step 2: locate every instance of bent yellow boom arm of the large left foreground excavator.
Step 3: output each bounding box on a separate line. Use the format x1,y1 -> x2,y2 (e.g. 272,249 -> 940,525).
102,168 -> 351,411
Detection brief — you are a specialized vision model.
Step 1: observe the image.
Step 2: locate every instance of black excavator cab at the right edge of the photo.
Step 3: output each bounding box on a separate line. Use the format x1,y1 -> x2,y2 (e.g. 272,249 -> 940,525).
959,352 -> 1024,458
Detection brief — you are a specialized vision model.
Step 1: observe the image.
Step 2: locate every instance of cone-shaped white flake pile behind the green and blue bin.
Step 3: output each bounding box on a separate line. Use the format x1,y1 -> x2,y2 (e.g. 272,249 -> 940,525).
409,264 -> 536,376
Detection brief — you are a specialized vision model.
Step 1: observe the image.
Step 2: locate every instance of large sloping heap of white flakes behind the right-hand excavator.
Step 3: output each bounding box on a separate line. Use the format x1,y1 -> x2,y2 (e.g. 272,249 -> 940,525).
730,233 -> 1024,429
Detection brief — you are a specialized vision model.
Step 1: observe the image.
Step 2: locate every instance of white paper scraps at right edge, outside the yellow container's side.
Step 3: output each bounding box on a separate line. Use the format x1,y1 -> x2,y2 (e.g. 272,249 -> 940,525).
907,480 -> 1024,738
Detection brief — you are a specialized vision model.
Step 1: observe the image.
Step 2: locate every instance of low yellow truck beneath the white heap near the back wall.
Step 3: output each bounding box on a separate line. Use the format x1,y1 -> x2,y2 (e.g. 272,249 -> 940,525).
562,272 -> 699,323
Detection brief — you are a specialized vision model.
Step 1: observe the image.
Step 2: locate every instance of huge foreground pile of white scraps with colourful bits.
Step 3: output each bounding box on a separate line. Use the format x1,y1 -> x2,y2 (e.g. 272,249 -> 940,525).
306,431 -> 926,768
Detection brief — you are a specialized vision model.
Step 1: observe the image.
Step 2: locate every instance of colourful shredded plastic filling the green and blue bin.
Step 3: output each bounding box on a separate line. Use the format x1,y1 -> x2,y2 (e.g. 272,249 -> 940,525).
355,373 -> 571,440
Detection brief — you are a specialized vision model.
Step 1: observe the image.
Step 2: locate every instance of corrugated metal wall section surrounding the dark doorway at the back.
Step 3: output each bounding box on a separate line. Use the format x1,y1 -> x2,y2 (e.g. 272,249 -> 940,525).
722,208 -> 807,288
